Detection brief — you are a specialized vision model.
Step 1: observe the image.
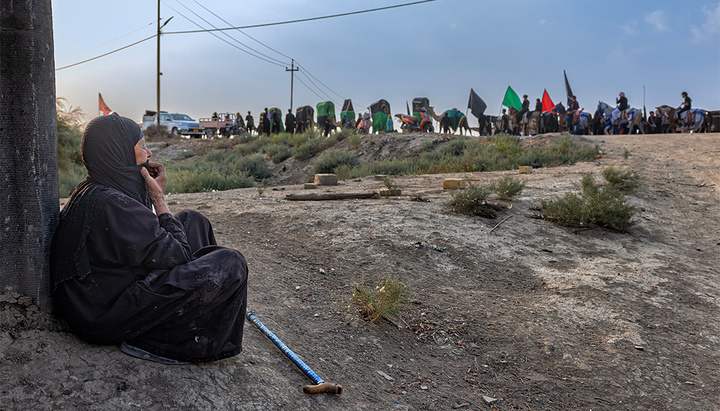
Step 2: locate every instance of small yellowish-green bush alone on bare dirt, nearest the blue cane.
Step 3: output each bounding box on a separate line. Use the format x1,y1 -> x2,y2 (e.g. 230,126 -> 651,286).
351,276 -> 410,322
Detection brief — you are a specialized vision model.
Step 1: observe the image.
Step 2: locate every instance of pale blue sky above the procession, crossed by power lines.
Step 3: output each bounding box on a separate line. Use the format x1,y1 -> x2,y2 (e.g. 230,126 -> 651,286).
52,0 -> 720,125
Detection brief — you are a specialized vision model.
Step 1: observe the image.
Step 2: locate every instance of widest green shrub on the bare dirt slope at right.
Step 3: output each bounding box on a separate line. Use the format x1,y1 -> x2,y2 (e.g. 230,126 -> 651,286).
541,173 -> 637,232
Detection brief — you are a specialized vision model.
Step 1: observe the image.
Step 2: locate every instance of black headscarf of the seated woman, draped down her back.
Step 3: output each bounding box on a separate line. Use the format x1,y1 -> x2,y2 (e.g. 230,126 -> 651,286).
50,114 -> 152,291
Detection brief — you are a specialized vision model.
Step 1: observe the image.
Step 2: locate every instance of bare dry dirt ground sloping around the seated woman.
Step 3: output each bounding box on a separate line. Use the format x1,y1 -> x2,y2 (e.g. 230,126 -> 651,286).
0,130 -> 720,410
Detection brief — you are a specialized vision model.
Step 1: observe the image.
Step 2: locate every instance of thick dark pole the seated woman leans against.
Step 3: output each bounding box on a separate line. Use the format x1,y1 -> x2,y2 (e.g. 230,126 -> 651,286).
0,0 -> 60,308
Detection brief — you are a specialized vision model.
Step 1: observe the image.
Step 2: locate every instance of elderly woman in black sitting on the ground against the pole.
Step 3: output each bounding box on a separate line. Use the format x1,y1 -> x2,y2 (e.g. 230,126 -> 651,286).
50,114 -> 247,364
